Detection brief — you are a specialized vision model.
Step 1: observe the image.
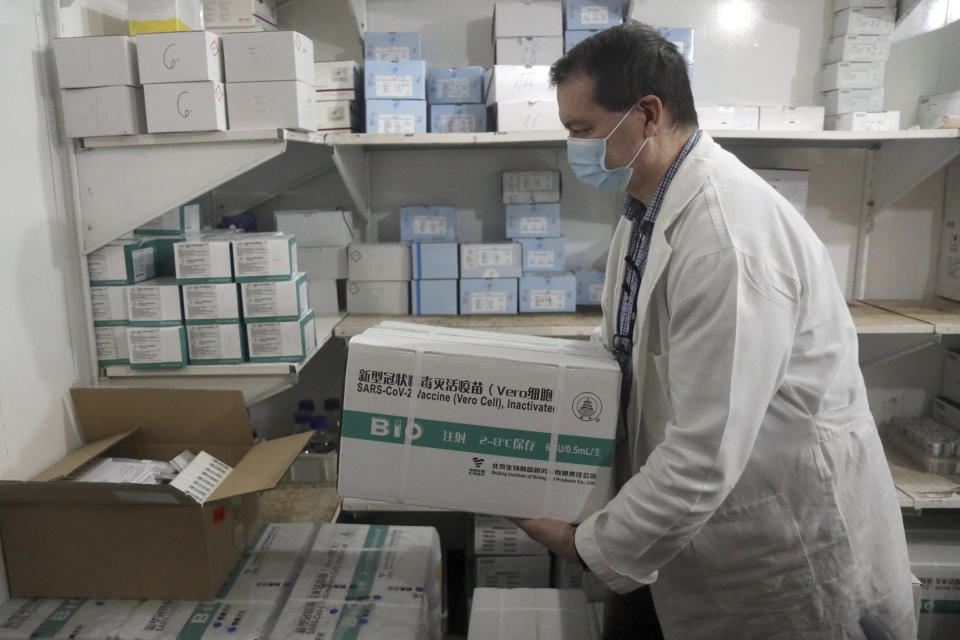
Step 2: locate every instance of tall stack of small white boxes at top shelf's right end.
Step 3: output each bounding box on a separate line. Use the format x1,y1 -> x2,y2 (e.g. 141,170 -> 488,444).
822,0 -> 900,131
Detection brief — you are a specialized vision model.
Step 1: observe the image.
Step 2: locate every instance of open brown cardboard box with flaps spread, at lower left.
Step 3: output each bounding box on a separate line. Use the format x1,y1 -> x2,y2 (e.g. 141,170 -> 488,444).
0,388 -> 310,600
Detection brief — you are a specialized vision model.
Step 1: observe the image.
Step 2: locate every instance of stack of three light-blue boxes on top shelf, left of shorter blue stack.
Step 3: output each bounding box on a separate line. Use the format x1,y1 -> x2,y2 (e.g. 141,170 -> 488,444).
363,31 -> 427,134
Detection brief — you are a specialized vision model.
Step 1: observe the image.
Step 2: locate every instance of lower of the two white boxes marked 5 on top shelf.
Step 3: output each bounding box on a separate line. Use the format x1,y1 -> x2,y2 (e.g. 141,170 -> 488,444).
227,80 -> 317,131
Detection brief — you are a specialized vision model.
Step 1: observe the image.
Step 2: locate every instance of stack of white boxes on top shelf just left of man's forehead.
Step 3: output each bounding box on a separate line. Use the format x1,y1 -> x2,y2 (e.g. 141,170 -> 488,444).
486,0 -> 563,131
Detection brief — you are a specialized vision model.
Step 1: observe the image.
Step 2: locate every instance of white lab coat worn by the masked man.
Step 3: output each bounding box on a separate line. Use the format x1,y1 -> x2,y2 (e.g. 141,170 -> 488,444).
576,133 -> 916,640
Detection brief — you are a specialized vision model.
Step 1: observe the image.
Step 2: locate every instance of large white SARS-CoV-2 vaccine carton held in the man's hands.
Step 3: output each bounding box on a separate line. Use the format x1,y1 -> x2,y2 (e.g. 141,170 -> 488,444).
338,328 -> 620,522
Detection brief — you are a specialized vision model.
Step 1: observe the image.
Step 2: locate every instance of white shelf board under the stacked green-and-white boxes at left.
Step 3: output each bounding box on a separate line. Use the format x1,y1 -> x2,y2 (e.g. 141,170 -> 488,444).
100,313 -> 345,405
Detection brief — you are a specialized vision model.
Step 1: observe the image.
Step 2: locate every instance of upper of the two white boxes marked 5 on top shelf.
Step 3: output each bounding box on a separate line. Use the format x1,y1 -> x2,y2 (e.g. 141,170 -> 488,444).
223,31 -> 316,85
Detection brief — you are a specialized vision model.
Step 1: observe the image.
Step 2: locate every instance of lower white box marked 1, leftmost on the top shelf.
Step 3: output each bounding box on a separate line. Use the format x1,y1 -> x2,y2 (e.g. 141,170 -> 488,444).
60,86 -> 147,138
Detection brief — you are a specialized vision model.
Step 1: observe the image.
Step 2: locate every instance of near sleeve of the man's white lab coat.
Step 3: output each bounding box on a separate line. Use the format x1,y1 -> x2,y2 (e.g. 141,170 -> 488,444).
575,248 -> 799,593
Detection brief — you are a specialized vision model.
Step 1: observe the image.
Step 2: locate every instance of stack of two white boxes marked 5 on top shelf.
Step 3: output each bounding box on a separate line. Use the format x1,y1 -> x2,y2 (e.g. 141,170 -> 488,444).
223,31 -> 317,131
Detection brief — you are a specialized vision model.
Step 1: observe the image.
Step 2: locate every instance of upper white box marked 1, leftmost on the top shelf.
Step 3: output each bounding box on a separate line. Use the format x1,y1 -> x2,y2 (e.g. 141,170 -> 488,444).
53,36 -> 140,89
